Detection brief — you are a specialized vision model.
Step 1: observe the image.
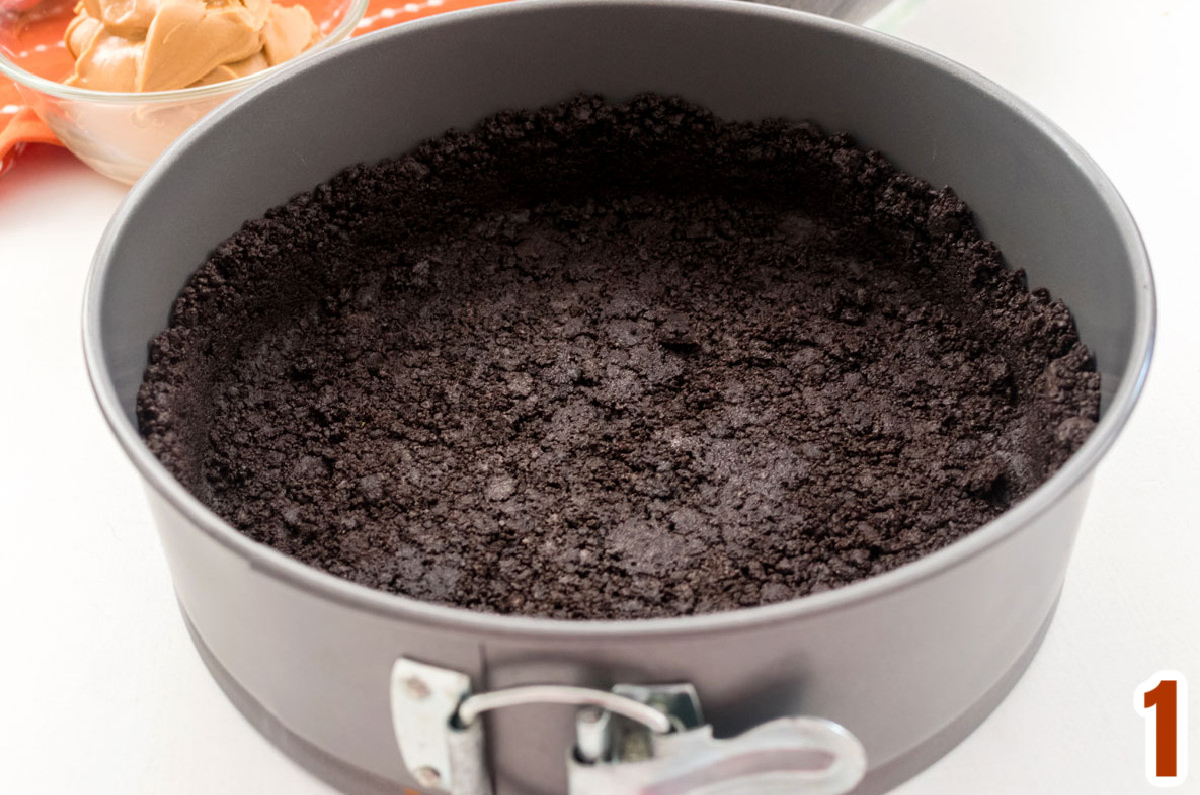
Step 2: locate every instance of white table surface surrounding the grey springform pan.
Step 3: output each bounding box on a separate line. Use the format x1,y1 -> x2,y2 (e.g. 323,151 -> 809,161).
0,0 -> 1200,795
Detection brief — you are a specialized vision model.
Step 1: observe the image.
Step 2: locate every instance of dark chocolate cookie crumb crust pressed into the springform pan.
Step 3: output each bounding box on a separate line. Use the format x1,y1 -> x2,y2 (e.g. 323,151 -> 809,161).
137,96 -> 1099,618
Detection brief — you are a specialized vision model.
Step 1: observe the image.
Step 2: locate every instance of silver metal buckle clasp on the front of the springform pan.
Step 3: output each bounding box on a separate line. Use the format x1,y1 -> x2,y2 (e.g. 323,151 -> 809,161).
391,658 -> 866,795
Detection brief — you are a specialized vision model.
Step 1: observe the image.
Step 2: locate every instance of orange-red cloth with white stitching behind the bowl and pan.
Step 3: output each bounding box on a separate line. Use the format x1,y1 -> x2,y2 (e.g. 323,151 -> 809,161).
0,0 -> 504,174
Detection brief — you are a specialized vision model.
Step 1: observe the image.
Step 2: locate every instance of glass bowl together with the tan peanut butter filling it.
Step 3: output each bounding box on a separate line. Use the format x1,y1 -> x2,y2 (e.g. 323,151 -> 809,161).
0,0 -> 370,184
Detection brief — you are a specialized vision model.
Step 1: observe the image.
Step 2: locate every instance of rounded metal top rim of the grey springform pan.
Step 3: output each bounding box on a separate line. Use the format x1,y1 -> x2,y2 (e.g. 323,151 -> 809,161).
82,0 -> 1156,641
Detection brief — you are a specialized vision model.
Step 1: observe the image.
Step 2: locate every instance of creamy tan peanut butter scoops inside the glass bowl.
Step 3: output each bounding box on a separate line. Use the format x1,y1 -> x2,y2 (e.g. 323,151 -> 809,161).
65,0 -> 318,91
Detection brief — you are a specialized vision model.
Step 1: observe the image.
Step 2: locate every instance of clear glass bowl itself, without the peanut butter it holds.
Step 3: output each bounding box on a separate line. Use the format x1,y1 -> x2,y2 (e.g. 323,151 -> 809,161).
0,0 -> 368,184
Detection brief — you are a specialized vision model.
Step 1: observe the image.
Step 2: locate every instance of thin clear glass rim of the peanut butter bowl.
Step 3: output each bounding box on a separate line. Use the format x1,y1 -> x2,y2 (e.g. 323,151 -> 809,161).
0,0 -> 371,104
